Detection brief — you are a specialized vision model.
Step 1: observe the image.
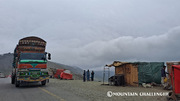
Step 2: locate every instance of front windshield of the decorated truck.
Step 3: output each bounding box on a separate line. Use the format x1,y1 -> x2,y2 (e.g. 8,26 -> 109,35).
20,53 -> 46,60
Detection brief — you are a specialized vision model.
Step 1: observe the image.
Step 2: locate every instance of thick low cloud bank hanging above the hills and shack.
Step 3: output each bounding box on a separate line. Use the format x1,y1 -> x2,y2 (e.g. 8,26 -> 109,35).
50,27 -> 180,68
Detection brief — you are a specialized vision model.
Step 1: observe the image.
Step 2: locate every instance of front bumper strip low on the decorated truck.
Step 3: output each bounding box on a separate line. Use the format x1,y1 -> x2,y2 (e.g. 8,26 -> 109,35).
17,77 -> 49,82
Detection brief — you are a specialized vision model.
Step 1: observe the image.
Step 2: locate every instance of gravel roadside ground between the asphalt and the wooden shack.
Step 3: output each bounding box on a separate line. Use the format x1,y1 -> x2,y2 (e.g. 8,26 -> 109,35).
48,79 -> 169,101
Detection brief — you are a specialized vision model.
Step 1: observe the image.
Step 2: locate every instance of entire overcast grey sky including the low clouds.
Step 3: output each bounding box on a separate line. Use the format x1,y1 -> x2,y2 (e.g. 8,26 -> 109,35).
0,0 -> 180,69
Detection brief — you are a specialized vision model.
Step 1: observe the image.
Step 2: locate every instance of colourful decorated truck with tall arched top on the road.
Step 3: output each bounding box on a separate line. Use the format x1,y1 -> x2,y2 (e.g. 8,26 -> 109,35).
11,36 -> 51,87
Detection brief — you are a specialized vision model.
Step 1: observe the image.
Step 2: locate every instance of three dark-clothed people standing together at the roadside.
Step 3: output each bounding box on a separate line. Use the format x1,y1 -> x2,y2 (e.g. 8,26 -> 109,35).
83,69 -> 95,82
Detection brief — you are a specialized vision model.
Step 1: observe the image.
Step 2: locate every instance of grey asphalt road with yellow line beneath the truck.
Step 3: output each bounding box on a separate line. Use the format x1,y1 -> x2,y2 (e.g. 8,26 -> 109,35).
0,78 -> 85,101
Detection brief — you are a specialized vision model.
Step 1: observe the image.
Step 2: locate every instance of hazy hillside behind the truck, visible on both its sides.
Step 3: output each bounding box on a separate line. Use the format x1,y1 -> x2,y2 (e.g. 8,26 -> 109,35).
0,53 -> 83,79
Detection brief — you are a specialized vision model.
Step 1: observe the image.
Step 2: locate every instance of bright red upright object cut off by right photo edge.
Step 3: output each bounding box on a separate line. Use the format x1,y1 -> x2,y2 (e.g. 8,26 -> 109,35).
171,65 -> 180,94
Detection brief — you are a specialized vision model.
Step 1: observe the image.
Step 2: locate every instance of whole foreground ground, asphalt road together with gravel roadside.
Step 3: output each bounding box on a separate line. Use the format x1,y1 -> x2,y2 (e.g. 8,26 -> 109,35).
0,78 -> 169,101
